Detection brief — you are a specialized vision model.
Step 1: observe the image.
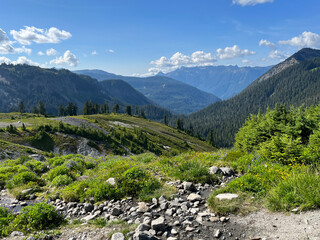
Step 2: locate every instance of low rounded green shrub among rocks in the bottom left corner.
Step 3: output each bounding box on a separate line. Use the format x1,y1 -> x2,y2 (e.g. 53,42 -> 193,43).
11,203 -> 65,233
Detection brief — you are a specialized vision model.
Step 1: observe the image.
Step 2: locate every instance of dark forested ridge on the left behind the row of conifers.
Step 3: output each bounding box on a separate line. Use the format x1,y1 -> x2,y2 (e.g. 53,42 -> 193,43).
0,64 -> 171,120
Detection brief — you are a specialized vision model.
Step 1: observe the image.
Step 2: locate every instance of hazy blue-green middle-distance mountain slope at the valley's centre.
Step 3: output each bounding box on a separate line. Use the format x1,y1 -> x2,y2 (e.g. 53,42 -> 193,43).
75,70 -> 220,114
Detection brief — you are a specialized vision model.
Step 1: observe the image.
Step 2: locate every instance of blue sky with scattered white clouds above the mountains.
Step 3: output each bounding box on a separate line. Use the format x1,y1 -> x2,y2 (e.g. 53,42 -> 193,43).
0,0 -> 320,75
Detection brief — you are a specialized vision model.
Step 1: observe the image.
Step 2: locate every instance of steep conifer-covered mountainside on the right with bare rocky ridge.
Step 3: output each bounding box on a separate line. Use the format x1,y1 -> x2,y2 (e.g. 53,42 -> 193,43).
188,49 -> 320,146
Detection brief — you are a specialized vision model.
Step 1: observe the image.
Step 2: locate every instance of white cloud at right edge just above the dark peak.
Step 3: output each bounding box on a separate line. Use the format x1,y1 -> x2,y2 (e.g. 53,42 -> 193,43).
279,32 -> 320,48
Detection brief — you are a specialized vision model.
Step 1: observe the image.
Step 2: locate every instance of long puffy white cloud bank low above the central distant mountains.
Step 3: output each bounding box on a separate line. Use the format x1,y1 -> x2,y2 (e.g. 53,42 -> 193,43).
148,51 -> 216,73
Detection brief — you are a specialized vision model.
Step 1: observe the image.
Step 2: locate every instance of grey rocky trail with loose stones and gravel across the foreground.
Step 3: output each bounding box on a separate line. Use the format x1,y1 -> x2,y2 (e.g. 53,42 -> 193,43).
0,166 -> 320,240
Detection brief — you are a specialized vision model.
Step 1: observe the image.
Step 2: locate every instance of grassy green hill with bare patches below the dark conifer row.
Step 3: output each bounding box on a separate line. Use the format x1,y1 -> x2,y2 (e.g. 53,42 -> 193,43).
0,113 -> 214,158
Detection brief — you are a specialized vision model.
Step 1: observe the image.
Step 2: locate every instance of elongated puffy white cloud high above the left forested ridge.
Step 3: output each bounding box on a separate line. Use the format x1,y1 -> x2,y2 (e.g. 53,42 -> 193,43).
10,26 -> 72,45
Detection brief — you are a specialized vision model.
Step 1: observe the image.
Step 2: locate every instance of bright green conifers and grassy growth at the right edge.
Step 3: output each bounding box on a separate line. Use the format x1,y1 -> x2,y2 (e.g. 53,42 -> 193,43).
209,105 -> 320,214
